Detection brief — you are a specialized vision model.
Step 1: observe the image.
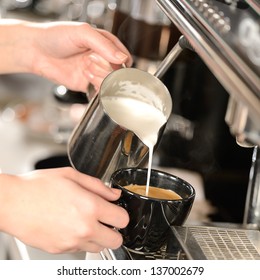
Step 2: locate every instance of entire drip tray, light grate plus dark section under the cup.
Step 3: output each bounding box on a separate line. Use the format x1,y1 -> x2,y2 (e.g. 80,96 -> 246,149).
101,224 -> 260,260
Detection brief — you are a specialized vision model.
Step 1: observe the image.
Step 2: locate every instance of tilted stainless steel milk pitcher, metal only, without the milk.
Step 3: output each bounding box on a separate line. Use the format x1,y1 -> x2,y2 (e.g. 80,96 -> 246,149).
68,68 -> 172,183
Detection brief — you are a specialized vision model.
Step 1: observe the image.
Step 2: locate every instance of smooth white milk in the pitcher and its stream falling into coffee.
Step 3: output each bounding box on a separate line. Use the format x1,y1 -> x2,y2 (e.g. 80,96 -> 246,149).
102,96 -> 167,196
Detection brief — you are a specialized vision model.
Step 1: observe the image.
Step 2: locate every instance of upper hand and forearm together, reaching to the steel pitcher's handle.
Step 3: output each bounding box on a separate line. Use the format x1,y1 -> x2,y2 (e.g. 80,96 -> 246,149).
0,19 -> 132,92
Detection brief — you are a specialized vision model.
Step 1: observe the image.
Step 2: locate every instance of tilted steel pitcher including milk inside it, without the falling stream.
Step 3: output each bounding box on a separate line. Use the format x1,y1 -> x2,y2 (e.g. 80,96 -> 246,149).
68,68 -> 172,183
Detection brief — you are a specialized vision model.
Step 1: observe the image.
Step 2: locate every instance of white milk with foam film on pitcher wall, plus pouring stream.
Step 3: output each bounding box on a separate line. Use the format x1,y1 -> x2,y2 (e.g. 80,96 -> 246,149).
102,81 -> 167,196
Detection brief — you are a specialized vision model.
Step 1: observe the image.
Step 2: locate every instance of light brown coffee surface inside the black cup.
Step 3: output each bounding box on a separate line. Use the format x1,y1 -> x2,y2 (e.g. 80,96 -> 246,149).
124,184 -> 182,200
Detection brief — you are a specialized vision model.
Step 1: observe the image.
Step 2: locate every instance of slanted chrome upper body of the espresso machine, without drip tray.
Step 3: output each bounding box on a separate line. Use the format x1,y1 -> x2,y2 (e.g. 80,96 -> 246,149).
154,0 -> 260,229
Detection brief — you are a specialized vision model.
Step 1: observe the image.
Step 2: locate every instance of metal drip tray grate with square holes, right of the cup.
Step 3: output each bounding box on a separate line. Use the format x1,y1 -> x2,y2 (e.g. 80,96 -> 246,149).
173,226 -> 260,260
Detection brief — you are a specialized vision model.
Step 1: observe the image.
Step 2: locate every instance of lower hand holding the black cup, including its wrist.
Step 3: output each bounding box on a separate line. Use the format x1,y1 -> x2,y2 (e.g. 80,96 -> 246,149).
0,167 -> 129,253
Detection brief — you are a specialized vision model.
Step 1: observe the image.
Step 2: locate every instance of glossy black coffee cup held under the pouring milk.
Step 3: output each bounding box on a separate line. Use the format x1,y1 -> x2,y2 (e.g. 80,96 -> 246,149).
110,168 -> 195,253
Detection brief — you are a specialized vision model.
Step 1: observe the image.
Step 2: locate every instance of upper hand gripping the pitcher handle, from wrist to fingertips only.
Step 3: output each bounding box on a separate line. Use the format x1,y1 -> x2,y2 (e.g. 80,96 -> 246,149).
30,22 -> 132,92
